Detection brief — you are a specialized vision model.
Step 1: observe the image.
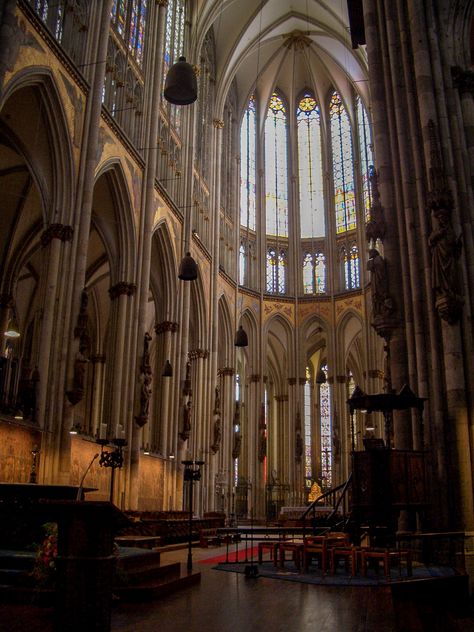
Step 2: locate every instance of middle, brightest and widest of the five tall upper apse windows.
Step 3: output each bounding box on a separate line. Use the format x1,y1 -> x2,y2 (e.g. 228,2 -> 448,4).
296,93 -> 325,238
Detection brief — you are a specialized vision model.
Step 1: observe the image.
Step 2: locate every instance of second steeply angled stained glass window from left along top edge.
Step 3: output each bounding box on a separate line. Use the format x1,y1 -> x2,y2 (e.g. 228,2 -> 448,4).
111,0 -> 147,64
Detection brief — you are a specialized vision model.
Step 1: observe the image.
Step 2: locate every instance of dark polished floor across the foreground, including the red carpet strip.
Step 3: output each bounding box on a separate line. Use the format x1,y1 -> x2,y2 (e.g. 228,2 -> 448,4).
0,547 -> 474,632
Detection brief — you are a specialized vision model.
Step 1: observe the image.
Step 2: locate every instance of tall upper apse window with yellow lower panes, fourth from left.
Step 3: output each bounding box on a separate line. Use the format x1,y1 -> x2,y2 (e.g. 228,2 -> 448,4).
329,92 -> 356,233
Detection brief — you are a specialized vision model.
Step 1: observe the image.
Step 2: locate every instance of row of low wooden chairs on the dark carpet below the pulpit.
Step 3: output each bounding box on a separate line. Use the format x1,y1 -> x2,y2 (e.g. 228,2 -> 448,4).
258,532 -> 412,580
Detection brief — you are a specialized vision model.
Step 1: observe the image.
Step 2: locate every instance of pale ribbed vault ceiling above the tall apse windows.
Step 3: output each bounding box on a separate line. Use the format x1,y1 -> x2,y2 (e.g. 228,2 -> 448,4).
196,0 -> 368,115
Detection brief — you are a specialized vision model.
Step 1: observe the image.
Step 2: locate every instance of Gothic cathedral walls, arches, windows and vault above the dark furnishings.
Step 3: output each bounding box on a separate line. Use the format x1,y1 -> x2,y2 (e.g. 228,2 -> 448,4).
0,0 -> 474,616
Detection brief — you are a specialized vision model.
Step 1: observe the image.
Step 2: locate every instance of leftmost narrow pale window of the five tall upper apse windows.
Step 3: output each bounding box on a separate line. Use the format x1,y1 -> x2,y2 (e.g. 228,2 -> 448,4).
240,96 -> 257,230
